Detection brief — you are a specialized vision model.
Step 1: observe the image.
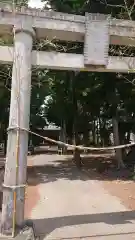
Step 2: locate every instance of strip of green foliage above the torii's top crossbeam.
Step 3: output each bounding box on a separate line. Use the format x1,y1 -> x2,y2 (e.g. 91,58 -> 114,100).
42,0 -> 135,18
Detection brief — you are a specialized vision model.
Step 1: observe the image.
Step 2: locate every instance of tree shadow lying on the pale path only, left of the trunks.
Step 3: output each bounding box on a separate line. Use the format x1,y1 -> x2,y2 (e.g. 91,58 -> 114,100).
27,159 -> 89,186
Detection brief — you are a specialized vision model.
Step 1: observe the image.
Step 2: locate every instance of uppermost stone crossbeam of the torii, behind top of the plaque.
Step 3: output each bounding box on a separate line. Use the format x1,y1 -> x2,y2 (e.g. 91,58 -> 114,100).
0,8 -> 135,46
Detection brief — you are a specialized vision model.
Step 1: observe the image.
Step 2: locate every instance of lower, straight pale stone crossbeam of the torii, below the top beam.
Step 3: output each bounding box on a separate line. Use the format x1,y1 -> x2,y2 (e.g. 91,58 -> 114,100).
0,46 -> 135,73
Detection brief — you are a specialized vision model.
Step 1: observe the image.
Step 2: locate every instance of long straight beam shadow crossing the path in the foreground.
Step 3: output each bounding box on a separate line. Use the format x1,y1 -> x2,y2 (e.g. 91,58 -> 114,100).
30,211 -> 135,239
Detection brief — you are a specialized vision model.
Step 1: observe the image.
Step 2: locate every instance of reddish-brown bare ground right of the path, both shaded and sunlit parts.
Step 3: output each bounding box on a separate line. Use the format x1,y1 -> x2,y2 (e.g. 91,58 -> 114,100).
80,153 -> 135,210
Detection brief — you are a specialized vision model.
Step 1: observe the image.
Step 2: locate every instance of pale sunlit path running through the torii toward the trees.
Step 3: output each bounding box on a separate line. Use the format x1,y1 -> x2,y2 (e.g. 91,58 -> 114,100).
26,155 -> 135,240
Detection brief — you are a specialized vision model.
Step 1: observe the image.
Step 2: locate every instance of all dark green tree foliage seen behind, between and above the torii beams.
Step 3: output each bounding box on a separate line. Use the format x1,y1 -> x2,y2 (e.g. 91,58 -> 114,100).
0,0 -> 135,152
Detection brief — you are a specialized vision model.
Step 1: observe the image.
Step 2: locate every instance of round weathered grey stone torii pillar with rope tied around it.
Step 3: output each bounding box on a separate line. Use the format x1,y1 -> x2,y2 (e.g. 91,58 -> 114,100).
1,20 -> 35,235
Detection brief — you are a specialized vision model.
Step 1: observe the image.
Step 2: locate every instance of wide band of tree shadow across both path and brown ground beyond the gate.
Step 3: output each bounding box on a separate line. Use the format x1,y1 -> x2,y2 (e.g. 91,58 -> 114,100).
28,154 -> 133,186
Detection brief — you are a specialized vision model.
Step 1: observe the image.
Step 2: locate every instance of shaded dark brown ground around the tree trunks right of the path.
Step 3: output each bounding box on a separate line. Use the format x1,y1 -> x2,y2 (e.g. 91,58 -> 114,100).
82,154 -> 133,181
